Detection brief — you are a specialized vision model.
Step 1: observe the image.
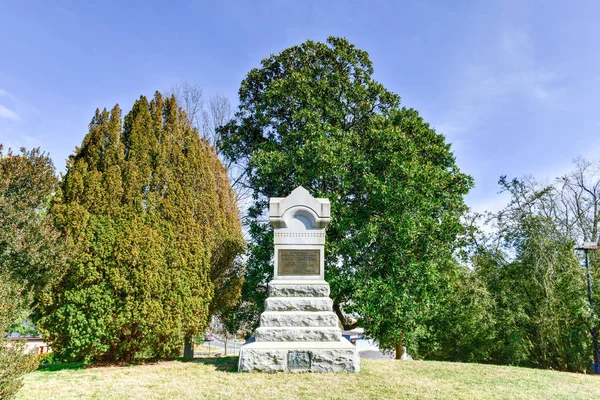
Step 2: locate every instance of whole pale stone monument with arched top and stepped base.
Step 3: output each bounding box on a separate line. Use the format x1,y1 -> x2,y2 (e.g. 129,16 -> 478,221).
238,187 -> 360,372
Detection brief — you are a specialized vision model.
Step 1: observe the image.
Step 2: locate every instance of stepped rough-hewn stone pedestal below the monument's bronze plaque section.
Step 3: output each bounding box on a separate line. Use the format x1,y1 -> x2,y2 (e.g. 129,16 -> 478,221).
238,280 -> 360,372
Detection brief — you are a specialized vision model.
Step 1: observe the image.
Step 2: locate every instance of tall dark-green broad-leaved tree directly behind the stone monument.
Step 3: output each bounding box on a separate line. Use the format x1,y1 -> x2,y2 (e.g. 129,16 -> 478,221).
220,37 -> 472,348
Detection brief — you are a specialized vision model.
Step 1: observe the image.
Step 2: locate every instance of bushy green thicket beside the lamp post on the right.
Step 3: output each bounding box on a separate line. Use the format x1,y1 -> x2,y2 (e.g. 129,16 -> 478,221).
419,178 -> 597,372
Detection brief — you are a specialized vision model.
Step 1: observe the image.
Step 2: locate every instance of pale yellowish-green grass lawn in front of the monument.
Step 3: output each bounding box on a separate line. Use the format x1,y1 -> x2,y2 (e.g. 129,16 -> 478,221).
17,357 -> 600,400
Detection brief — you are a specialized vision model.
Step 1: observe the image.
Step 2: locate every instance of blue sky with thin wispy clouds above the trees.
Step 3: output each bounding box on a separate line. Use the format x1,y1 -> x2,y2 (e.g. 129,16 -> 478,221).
0,0 -> 600,211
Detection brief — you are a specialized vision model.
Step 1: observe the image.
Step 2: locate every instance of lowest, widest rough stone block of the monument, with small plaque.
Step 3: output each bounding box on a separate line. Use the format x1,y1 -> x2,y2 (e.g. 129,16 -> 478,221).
238,338 -> 360,372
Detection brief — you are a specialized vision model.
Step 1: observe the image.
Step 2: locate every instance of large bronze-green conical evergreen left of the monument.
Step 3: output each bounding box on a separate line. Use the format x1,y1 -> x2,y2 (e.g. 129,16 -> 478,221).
40,93 -> 243,360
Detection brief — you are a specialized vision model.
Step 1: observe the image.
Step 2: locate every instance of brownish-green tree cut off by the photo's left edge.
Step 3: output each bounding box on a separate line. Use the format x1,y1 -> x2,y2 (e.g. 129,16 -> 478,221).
0,147 -> 65,313
